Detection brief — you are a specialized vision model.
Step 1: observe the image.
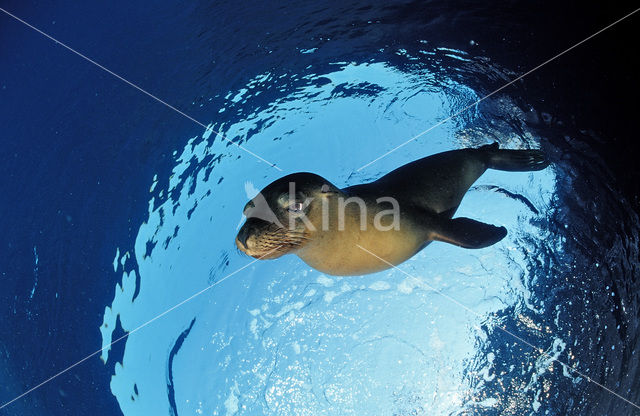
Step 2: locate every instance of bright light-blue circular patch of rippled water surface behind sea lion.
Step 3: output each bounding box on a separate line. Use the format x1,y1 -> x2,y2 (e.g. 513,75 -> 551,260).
102,49 -> 632,415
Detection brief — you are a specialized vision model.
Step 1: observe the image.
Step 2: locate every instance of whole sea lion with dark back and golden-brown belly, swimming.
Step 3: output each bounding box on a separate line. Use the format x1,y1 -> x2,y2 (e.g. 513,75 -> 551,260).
236,143 -> 549,275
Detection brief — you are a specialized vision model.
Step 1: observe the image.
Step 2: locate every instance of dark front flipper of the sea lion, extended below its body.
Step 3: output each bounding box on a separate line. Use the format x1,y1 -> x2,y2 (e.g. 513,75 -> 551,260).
431,217 -> 507,248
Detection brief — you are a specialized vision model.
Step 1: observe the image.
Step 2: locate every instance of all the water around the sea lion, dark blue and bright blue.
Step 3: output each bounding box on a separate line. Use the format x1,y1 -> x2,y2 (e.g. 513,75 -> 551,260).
0,1 -> 640,415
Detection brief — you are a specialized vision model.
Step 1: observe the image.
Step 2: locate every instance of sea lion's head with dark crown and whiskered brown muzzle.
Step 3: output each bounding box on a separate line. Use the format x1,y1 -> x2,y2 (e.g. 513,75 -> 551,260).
236,172 -> 339,259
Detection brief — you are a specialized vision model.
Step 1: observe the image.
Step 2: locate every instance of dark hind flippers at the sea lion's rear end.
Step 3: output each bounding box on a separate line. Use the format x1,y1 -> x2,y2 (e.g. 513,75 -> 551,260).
478,143 -> 549,172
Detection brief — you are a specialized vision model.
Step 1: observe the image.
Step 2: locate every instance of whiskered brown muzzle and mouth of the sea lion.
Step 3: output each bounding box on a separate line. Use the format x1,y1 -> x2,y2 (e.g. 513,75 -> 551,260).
236,218 -> 309,260
